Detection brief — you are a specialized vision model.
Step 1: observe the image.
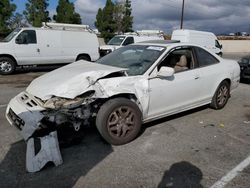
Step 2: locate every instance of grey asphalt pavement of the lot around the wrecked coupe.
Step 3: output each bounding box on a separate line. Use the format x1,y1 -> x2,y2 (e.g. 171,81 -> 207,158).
0,57 -> 250,188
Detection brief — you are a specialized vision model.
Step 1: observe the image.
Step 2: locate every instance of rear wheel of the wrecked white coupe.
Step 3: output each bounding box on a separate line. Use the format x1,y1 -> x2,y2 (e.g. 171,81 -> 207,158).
210,80 -> 230,110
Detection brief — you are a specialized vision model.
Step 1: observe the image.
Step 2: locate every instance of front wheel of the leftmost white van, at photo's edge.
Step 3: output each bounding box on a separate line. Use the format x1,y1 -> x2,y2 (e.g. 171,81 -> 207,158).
0,57 -> 16,75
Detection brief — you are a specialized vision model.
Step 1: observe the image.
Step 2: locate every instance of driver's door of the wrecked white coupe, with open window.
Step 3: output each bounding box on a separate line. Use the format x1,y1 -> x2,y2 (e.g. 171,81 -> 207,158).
148,48 -> 202,118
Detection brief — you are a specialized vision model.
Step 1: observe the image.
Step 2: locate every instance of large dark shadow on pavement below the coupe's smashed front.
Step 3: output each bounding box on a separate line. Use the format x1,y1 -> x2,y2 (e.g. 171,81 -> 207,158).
0,128 -> 113,188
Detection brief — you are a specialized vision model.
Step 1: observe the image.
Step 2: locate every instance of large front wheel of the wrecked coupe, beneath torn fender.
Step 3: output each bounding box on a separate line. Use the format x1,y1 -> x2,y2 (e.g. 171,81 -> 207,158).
96,98 -> 142,145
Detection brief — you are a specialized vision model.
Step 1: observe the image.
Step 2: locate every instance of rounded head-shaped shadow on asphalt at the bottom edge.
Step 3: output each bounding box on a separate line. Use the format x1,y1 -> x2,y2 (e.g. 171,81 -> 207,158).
158,161 -> 203,188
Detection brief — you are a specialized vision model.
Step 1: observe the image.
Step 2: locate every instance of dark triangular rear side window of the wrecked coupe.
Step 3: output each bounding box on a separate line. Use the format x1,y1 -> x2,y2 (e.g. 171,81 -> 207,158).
195,47 -> 219,67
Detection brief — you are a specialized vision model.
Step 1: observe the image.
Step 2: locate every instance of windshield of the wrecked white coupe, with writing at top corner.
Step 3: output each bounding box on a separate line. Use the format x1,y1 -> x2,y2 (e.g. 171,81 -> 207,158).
97,45 -> 165,76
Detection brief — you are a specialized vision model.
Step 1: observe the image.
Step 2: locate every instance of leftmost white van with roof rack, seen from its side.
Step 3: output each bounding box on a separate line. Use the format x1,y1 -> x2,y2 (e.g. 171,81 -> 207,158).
0,23 -> 100,74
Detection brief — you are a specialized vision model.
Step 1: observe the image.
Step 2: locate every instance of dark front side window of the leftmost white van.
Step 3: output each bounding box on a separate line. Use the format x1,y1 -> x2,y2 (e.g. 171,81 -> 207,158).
16,30 -> 37,44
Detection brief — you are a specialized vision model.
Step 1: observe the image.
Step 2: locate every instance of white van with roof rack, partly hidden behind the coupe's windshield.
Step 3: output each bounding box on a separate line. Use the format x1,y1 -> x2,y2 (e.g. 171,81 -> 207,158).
100,30 -> 164,57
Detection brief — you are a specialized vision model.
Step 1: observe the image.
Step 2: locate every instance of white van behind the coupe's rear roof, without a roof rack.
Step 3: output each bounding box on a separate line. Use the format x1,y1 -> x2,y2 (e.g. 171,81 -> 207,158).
171,29 -> 222,56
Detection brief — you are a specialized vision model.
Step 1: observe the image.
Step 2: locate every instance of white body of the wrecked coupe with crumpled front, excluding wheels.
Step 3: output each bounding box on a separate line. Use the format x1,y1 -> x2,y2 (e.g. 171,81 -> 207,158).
6,43 -> 240,171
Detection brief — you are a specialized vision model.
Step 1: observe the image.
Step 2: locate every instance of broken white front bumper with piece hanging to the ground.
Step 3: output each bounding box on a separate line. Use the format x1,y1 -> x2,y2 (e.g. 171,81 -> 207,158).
6,92 -> 62,172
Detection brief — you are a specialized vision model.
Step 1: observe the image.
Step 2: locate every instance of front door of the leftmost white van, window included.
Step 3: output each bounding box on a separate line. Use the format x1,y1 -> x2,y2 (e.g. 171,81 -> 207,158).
14,30 -> 40,65
